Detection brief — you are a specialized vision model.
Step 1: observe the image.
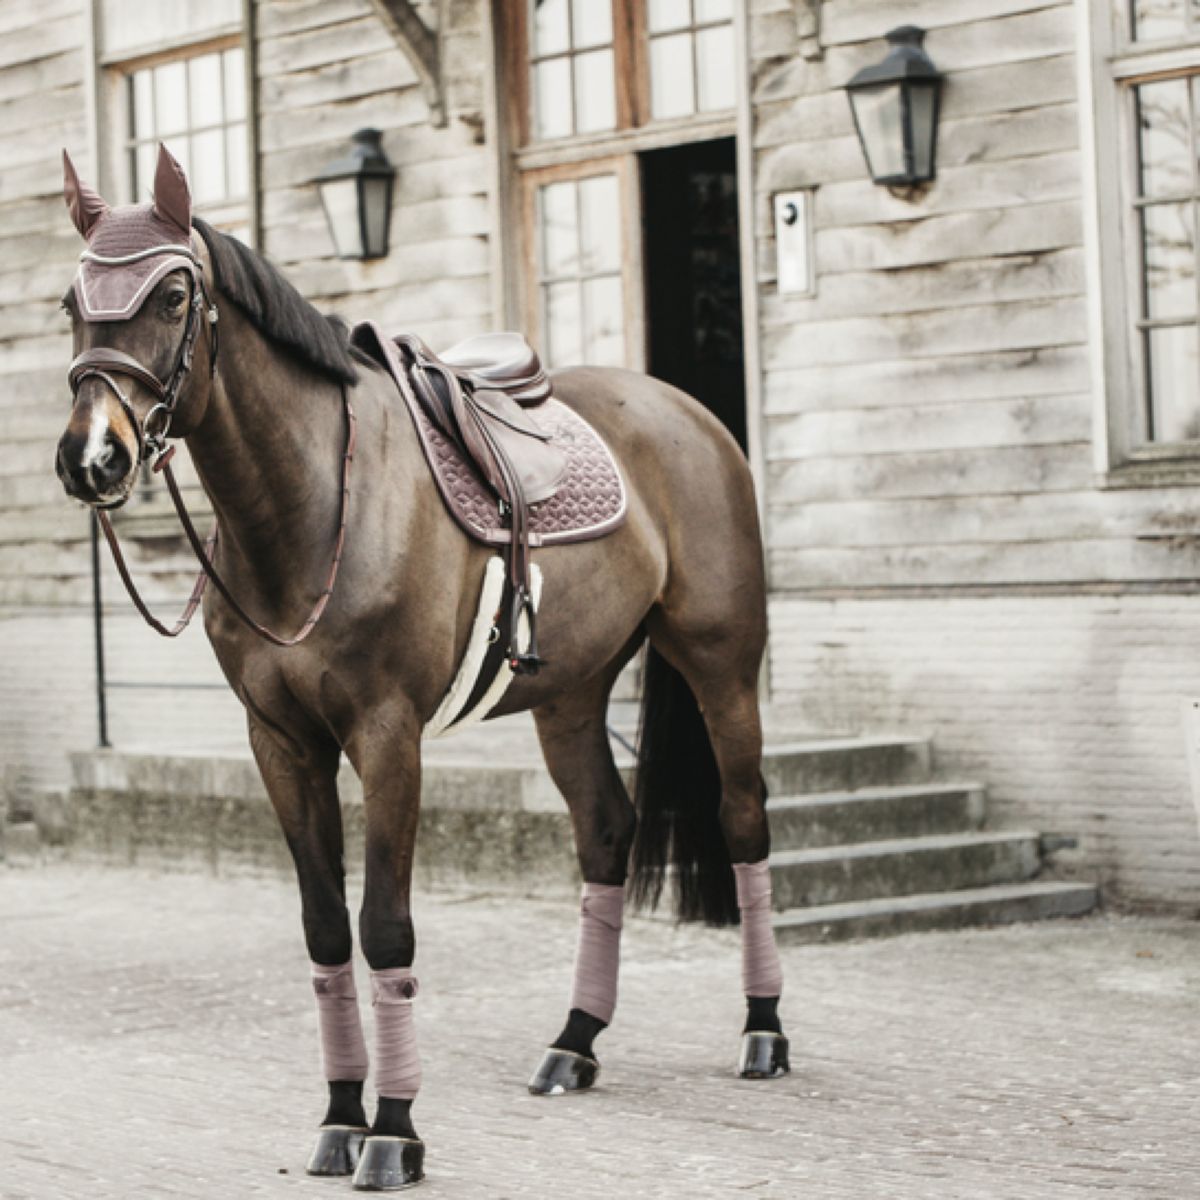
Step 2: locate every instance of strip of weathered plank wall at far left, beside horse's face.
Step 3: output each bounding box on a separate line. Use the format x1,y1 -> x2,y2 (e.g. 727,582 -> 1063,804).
0,0 -> 95,610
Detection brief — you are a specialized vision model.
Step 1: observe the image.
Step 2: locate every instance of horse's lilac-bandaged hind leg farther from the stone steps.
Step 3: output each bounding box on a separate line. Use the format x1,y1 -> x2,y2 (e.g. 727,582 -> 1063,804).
529,672 -> 636,1096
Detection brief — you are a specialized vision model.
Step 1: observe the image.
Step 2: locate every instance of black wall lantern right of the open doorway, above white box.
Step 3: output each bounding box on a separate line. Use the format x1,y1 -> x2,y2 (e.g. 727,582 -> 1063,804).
846,25 -> 942,187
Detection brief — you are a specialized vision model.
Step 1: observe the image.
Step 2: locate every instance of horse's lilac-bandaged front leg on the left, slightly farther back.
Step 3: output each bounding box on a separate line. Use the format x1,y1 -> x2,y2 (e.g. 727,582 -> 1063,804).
250,719 -> 367,1175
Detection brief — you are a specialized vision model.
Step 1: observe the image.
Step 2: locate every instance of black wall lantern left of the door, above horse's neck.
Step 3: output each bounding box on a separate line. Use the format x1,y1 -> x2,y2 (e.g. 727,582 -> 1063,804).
317,130 -> 396,258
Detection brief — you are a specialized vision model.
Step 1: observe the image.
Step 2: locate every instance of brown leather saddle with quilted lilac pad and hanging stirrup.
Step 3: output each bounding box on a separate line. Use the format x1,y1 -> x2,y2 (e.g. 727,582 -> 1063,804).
352,322 -> 625,674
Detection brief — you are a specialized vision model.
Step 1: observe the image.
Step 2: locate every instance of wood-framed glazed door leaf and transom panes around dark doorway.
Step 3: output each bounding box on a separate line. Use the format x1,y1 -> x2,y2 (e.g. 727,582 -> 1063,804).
494,0 -> 737,368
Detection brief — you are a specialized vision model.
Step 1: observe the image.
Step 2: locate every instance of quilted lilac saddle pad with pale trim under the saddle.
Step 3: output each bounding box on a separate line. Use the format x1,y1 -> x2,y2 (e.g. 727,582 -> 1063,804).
354,324 -> 626,546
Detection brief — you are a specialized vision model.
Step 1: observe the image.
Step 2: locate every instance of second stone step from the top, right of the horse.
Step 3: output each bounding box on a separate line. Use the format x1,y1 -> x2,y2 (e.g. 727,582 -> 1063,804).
768,784 -> 985,850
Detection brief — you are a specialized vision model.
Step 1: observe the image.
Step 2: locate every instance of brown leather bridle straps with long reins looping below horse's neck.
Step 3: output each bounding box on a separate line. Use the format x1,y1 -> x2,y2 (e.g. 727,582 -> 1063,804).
67,274 -> 358,647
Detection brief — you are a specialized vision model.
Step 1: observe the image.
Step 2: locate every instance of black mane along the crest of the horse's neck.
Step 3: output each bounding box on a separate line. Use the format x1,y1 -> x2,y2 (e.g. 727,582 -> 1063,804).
192,217 -> 359,384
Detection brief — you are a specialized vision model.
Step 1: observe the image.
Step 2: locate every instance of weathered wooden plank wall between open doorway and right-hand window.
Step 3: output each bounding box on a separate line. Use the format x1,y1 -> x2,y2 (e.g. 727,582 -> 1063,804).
749,0 -> 1200,594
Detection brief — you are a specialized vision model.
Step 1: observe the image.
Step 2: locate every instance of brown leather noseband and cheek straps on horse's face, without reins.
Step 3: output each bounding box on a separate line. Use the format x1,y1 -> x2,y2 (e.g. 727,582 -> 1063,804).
67,262 -> 217,464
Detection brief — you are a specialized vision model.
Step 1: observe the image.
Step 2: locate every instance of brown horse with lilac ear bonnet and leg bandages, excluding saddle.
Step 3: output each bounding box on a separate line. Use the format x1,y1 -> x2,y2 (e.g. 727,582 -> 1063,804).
55,146 -> 788,1190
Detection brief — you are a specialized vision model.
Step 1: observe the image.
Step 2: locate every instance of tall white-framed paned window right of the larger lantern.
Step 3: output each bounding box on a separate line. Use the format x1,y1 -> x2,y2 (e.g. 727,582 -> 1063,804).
1093,0 -> 1200,470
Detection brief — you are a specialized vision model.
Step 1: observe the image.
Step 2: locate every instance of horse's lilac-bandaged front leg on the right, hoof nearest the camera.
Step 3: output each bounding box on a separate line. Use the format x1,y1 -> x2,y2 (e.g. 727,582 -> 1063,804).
347,713 -> 425,1192
